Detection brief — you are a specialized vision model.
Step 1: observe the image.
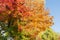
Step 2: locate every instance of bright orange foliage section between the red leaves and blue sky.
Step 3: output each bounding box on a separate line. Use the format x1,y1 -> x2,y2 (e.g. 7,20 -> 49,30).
18,1 -> 53,37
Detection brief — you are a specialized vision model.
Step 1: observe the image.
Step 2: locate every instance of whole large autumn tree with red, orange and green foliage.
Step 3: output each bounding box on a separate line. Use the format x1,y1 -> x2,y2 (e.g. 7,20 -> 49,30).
0,0 -> 53,40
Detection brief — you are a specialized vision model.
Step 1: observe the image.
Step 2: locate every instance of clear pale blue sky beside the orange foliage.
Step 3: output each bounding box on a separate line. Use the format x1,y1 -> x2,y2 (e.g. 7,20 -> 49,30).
46,0 -> 60,33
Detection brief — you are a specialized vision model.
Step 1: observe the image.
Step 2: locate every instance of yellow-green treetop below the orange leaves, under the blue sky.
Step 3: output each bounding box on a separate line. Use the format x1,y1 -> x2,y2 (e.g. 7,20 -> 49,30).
36,28 -> 58,40
